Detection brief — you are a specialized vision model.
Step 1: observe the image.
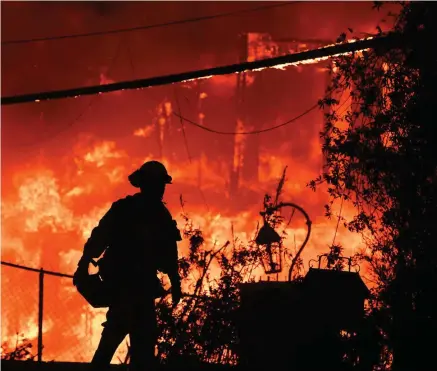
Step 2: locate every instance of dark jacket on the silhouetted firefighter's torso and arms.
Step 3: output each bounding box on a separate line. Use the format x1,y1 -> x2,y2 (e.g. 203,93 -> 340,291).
84,193 -> 181,291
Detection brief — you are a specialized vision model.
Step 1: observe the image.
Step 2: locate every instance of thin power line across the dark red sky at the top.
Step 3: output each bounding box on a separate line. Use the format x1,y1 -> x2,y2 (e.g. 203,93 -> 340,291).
1,1 -> 300,46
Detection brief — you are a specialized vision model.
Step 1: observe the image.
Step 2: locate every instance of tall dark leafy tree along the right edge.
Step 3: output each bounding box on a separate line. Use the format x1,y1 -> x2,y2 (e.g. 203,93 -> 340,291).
309,2 -> 437,370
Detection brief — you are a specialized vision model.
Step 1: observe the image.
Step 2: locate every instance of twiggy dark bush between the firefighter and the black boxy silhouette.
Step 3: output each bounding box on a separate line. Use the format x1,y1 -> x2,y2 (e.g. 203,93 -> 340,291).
157,201 -> 259,364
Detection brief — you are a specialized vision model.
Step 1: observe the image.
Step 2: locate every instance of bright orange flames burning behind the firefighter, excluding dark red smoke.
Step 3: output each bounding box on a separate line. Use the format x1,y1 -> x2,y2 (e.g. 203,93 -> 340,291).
1,39 -> 374,361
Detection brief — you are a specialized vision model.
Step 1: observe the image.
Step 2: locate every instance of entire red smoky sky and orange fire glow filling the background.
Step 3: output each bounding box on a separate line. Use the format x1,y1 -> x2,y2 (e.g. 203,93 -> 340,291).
1,2 -> 396,361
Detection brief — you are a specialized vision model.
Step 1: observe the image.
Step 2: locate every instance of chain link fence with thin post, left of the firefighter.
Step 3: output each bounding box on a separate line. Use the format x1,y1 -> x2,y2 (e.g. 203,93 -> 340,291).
1,261 -> 127,363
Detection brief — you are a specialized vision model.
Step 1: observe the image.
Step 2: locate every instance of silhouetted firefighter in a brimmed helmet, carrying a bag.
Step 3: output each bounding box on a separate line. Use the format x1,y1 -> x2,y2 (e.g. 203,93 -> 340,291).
74,161 -> 181,371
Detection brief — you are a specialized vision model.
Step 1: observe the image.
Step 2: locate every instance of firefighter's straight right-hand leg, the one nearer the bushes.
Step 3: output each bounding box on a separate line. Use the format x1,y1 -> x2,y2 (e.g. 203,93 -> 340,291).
129,299 -> 157,371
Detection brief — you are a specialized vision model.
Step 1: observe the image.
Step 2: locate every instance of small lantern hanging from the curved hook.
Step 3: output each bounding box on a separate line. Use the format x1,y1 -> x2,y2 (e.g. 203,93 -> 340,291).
255,221 -> 282,274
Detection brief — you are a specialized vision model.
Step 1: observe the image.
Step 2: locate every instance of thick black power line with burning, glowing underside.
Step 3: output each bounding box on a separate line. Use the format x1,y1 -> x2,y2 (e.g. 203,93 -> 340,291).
1,34 -> 399,105
